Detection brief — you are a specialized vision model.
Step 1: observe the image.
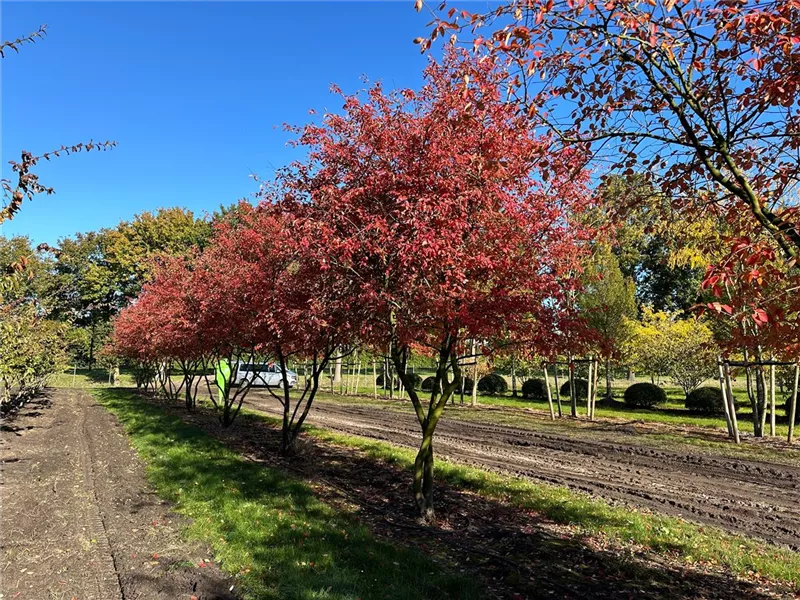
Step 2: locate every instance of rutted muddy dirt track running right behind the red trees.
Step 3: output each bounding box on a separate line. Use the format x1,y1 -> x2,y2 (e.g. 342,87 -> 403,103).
247,392 -> 800,550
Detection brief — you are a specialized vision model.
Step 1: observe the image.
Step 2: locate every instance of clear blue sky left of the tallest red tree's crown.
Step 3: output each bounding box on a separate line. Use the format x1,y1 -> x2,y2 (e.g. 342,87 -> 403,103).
0,0 -> 438,243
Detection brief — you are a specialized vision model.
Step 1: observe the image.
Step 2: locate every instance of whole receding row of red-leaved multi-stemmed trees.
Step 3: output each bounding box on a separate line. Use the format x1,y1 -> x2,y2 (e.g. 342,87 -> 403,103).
114,50 -> 592,518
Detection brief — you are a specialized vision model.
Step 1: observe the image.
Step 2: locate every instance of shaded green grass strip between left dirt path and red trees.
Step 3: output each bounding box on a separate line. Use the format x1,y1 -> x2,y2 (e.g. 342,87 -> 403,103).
94,389 -> 481,600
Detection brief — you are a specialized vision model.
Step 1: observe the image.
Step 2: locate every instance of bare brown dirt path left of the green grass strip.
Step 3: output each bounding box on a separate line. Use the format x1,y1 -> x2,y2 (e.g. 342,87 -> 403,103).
0,390 -> 234,600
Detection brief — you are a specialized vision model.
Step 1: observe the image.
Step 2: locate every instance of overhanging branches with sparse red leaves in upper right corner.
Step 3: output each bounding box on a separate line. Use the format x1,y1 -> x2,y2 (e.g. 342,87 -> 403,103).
424,0 -> 800,257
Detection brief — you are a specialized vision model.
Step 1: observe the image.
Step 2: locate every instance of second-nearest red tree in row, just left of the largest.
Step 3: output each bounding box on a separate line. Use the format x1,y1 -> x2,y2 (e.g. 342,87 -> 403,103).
202,204 -> 358,454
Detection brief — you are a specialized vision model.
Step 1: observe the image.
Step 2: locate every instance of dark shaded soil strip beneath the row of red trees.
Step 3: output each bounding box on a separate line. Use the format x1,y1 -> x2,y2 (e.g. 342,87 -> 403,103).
108,400 -> 792,600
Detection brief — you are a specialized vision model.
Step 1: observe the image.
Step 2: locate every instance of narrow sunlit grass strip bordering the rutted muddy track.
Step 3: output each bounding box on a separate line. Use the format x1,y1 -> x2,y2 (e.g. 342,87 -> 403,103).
241,412 -> 800,589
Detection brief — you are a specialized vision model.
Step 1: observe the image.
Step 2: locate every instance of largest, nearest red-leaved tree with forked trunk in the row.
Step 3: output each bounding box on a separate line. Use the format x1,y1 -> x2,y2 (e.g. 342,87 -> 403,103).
288,50 -> 590,519
